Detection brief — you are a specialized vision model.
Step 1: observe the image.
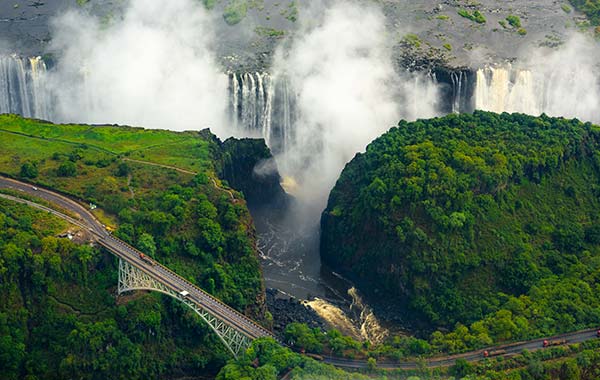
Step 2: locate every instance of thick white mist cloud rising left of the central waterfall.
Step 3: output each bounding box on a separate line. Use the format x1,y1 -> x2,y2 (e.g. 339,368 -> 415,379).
50,0 -> 227,132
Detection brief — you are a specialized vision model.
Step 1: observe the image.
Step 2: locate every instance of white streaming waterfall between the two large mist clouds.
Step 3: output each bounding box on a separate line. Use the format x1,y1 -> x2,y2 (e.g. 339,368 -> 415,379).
229,72 -> 294,153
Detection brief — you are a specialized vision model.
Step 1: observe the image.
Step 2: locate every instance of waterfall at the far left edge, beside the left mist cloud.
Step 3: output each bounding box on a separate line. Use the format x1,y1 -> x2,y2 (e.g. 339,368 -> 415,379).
0,55 -> 50,119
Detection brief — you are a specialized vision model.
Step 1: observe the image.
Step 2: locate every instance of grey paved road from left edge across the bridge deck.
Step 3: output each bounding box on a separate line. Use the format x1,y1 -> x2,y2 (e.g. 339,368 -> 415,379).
0,176 -> 275,339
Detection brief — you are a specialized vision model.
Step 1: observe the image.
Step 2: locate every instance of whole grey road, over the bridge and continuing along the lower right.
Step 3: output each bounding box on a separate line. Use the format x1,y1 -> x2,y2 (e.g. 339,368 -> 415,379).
0,176 -> 598,369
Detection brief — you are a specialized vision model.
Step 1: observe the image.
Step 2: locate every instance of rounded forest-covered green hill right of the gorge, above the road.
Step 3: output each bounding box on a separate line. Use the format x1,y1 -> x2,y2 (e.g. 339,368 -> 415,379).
321,112 -> 600,342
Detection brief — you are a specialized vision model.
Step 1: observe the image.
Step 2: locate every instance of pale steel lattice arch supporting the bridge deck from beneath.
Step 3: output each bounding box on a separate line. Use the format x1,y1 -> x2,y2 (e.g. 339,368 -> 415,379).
118,258 -> 252,358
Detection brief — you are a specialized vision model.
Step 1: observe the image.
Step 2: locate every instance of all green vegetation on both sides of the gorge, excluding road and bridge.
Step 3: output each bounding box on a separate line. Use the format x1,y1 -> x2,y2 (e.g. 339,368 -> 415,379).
0,112 -> 600,380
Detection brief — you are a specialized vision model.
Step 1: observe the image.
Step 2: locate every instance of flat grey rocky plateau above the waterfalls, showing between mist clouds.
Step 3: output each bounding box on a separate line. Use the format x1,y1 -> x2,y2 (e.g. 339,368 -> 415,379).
0,0 -> 586,71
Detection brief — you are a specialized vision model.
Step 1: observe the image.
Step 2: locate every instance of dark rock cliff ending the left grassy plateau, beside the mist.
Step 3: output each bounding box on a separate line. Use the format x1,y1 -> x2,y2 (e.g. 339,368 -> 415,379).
221,138 -> 287,208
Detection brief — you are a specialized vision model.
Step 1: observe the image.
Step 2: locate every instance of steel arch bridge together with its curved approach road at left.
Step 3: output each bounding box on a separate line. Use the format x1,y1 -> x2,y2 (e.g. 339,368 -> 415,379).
0,180 -> 281,357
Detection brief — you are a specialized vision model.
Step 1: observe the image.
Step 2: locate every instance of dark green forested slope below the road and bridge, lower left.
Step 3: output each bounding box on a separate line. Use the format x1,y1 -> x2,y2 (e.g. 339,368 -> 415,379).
0,200 -> 239,380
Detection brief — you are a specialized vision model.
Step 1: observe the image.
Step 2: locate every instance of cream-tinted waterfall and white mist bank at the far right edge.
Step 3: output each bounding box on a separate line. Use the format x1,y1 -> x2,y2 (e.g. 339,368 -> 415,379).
474,33 -> 600,122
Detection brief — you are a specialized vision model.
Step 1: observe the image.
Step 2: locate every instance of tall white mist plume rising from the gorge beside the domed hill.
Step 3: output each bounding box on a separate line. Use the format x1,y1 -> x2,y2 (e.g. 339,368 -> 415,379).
275,1 -> 437,211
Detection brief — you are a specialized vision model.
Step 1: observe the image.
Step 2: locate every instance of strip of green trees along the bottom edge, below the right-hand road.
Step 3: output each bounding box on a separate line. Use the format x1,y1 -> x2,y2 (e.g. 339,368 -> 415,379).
217,324 -> 600,380
